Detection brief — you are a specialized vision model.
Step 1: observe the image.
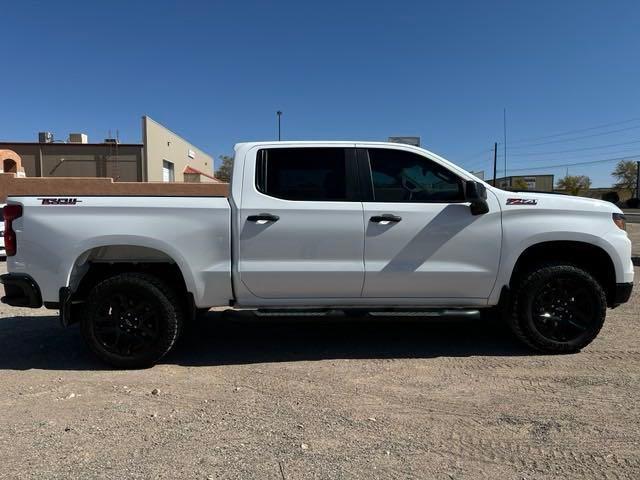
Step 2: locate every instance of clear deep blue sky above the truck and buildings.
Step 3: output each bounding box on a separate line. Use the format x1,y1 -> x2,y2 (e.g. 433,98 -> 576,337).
0,0 -> 640,186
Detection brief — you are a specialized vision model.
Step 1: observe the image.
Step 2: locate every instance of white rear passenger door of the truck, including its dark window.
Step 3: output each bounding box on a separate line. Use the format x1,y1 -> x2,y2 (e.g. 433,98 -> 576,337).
237,144 -> 364,299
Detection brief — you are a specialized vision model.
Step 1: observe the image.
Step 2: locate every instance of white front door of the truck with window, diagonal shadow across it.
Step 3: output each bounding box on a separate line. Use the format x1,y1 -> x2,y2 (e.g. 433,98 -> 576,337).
358,148 -> 502,304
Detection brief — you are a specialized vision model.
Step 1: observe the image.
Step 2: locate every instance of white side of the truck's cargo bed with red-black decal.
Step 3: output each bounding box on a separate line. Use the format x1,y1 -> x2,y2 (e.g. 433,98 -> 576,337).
7,194 -> 232,307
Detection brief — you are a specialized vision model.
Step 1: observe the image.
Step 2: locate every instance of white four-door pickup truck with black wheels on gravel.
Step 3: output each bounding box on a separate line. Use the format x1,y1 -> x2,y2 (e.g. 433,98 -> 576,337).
1,142 -> 634,367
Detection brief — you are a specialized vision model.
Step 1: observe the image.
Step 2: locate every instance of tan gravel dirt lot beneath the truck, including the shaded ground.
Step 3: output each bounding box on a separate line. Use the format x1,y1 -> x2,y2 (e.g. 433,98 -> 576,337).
0,265 -> 640,480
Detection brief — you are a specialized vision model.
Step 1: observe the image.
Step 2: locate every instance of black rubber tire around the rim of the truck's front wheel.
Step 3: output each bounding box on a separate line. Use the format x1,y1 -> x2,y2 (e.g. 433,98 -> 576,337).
506,263 -> 607,353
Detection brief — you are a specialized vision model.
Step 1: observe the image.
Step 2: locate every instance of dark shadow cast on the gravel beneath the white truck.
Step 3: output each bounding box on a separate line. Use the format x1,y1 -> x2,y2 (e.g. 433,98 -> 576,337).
0,312 -> 532,370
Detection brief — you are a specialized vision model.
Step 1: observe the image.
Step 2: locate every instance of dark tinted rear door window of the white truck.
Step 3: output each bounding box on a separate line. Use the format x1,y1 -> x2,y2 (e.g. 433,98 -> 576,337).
256,148 -> 347,201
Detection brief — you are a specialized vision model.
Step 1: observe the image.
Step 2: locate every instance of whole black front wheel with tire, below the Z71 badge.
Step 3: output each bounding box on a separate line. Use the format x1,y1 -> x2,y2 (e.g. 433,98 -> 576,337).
509,264 -> 607,353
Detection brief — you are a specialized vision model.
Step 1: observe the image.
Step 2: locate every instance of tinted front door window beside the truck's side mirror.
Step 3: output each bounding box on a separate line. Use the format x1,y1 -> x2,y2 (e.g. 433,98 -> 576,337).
369,148 -> 464,203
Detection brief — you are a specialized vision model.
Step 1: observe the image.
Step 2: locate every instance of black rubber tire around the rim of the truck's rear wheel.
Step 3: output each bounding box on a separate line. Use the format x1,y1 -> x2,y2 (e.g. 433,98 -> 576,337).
81,273 -> 184,368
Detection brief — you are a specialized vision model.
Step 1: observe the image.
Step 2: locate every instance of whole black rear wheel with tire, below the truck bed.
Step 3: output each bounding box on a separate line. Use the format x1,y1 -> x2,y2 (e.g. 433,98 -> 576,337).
81,273 -> 183,368
